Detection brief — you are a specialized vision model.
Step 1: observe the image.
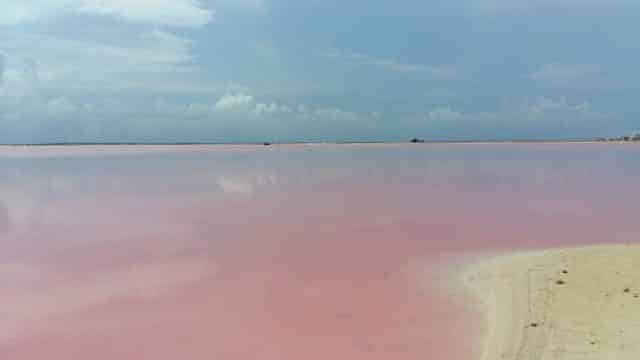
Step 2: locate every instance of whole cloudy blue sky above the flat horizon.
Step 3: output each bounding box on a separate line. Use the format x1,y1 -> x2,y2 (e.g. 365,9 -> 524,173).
0,0 -> 640,143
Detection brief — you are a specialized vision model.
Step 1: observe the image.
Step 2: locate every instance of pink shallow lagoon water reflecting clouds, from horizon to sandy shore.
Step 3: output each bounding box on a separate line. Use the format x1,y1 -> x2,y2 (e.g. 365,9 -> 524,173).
0,144 -> 640,360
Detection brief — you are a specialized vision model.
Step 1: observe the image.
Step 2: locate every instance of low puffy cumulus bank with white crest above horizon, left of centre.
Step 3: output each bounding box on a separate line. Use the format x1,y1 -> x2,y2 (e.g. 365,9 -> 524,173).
120,92 -> 383,142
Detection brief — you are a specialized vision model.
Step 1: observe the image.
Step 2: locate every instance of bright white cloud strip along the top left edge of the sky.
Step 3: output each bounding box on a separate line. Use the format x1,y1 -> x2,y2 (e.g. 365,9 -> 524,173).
0,0 -> 215,27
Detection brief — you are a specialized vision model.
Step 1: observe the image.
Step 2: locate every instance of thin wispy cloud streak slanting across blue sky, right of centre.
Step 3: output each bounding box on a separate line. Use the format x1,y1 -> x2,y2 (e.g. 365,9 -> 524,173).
323,49 -> 459,77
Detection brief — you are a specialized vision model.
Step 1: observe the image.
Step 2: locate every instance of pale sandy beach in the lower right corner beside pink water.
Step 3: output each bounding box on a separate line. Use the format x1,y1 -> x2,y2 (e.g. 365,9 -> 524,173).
463,245 -> 640,360
